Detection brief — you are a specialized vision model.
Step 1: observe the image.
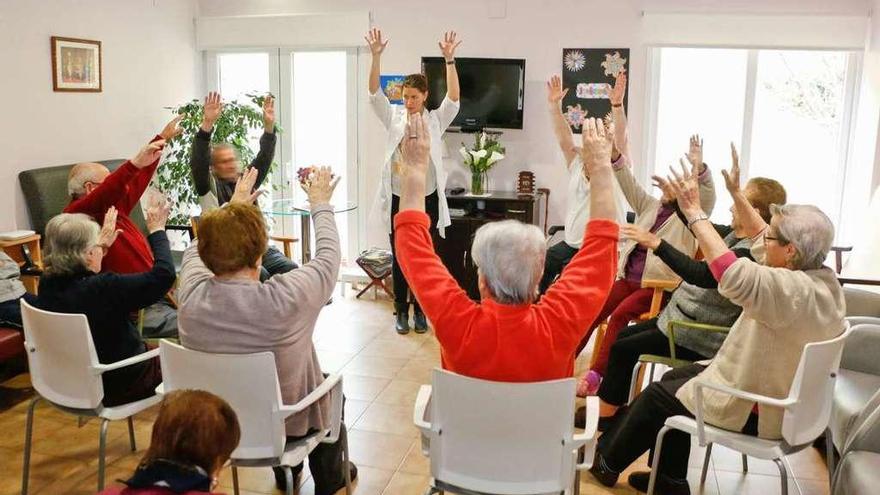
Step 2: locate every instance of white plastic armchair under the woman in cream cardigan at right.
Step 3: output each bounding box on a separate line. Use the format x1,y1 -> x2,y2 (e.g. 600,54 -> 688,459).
648,323 -> 850,495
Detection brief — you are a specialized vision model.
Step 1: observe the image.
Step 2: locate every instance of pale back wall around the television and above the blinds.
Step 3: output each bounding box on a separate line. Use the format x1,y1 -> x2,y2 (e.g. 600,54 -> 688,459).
199,0 -> 868,252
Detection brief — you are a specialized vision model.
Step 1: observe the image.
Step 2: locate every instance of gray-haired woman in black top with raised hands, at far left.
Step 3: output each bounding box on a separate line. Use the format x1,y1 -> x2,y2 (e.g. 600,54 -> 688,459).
37,206 -> 174,406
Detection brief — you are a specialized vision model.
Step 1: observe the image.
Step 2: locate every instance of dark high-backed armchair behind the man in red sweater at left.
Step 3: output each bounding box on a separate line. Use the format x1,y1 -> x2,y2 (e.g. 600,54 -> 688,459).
18,159 -> 146,235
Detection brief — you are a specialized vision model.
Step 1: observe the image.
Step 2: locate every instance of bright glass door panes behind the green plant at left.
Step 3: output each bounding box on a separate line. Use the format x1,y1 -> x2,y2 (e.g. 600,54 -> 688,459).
206,48 -> 365,259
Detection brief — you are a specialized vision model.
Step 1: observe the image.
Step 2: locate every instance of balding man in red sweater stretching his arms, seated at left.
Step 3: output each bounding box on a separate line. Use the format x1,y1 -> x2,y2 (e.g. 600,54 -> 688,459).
64,117 -> 183,337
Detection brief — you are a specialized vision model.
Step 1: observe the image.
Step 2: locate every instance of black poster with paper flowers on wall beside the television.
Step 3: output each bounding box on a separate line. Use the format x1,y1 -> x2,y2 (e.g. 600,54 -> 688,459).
562,48 -> 629,133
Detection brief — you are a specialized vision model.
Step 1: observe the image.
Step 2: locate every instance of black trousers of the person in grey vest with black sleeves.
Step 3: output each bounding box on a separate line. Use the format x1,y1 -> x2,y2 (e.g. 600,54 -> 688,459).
598,318 -> 709,406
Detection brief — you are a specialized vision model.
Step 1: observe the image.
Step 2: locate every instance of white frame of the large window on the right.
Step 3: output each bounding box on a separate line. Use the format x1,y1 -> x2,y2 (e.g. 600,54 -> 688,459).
636,44 -> 868,245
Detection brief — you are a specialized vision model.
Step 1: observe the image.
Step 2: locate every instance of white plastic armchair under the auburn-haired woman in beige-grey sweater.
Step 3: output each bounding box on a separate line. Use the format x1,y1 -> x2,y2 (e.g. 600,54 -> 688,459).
159,340 -> 351,495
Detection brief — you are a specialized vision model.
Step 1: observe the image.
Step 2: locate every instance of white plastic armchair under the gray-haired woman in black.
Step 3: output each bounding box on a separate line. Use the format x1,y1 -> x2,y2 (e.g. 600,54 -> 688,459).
21,299 -> 161,495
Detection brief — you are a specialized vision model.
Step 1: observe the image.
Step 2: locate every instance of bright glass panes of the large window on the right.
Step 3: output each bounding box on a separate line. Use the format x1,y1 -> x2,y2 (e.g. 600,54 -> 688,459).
647,48 -> 857,232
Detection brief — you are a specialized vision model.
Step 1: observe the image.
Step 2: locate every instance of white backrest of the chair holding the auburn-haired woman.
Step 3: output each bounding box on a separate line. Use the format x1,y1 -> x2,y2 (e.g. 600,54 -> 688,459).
159,340 -> 287,459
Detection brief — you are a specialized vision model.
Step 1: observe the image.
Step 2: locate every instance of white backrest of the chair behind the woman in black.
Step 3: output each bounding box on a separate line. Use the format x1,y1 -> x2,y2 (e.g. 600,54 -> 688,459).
21,299 -> 104,409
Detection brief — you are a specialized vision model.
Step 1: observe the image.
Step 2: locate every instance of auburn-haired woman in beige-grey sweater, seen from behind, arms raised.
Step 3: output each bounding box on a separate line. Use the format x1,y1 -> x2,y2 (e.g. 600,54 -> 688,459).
178,167 -> 357,495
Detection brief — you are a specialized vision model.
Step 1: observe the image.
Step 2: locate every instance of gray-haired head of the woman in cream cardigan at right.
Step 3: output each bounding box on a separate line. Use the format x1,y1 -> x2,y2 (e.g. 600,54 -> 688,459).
770,205 -> 834,270
